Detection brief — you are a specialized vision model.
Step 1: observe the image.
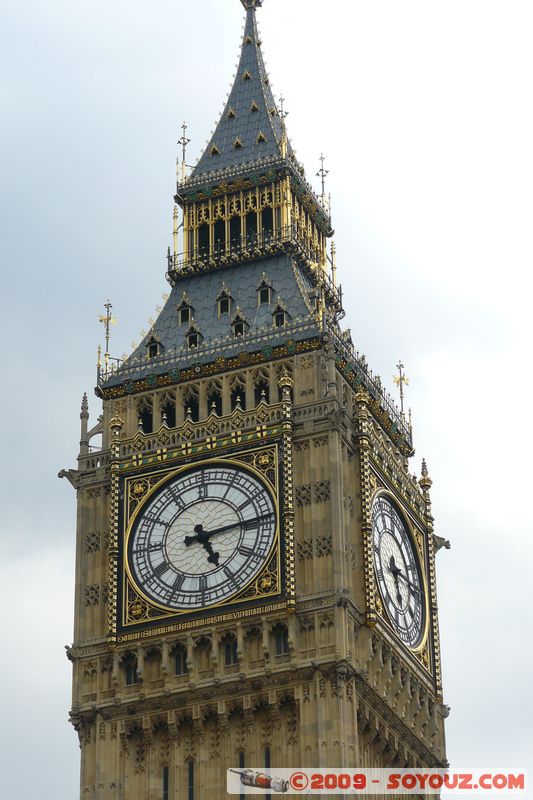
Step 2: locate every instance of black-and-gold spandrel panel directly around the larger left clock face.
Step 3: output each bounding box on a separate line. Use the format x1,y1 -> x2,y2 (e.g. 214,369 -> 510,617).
122,450 -> 282,627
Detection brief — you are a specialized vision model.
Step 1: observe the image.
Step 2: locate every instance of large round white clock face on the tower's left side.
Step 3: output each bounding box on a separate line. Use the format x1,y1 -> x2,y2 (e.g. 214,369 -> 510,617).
127,463 -> 277,611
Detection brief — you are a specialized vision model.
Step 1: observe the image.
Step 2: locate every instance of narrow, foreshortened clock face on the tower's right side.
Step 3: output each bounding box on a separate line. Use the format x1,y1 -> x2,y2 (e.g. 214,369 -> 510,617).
372,496 -> 426,648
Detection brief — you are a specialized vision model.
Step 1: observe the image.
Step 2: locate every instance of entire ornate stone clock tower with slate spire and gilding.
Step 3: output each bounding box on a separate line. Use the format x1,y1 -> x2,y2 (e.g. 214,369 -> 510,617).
61,0 -> 445,800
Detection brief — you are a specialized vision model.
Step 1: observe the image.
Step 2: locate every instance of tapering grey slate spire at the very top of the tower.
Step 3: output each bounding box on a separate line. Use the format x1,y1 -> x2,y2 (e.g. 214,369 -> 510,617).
191,0 -> 292,179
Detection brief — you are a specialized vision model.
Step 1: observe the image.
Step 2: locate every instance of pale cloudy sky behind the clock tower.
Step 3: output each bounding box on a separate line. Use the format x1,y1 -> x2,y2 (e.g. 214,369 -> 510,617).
0,0 -> 533,800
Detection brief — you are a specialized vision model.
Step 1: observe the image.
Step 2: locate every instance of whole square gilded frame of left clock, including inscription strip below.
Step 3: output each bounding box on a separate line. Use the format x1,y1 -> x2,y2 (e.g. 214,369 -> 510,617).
108,434 -> 294,641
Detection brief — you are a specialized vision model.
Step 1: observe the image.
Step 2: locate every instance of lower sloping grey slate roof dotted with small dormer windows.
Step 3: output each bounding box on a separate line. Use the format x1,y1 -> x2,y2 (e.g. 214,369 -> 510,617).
103,255 -> 318,387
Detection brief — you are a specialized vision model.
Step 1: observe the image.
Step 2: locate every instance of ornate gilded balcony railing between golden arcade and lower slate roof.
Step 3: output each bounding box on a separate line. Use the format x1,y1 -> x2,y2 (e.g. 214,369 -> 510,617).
167,223 -> 342,312
